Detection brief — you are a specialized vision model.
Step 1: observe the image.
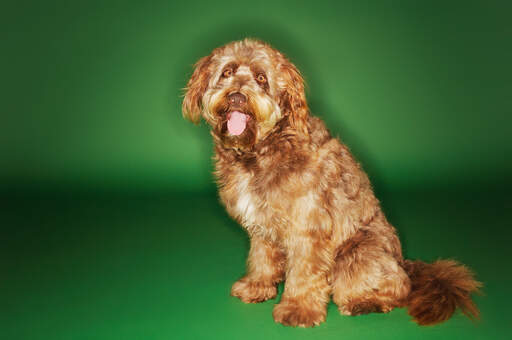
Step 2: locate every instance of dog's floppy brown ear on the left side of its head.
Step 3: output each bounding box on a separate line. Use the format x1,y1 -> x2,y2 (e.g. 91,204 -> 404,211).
182,55 -> 211,124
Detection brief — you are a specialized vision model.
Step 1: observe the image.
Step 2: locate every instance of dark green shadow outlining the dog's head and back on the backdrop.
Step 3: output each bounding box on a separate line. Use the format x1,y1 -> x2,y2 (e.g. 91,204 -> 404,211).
169,19 -> 406,253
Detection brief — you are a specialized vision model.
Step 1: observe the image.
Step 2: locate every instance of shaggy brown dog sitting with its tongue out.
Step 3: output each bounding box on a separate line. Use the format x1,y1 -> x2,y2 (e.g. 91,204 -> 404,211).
182,39 -> 481,327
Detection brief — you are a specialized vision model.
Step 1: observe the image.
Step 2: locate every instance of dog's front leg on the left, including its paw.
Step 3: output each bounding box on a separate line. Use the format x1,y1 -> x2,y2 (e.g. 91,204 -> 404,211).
231,235 -> 284,303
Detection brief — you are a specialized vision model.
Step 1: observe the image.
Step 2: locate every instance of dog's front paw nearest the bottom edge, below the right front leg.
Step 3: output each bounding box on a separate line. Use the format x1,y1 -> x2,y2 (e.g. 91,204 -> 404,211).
272,299 -> 327,327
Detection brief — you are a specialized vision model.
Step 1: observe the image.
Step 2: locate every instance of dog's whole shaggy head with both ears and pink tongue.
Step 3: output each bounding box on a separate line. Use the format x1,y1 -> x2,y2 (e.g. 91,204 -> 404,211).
183,39 -> 308,149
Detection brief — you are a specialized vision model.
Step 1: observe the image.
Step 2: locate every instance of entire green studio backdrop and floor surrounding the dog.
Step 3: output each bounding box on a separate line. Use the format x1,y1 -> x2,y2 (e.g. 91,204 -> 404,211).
0,1 -> 512,340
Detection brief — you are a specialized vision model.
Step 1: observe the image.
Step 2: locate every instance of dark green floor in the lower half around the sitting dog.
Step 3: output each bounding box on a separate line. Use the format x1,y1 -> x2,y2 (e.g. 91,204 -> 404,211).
0,190 -> 512,340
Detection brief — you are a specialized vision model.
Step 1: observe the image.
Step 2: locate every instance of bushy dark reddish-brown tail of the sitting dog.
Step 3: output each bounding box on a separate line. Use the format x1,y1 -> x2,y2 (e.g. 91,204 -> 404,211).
404,260 -> 482,325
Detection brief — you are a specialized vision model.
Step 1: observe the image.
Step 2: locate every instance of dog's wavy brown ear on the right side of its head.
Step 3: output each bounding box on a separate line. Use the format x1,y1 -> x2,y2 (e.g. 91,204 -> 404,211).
279,61 -> 309,135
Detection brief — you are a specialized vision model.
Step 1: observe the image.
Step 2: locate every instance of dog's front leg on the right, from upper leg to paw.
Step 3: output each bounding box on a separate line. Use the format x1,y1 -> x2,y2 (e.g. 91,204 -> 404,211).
273,232 -> 331,327
